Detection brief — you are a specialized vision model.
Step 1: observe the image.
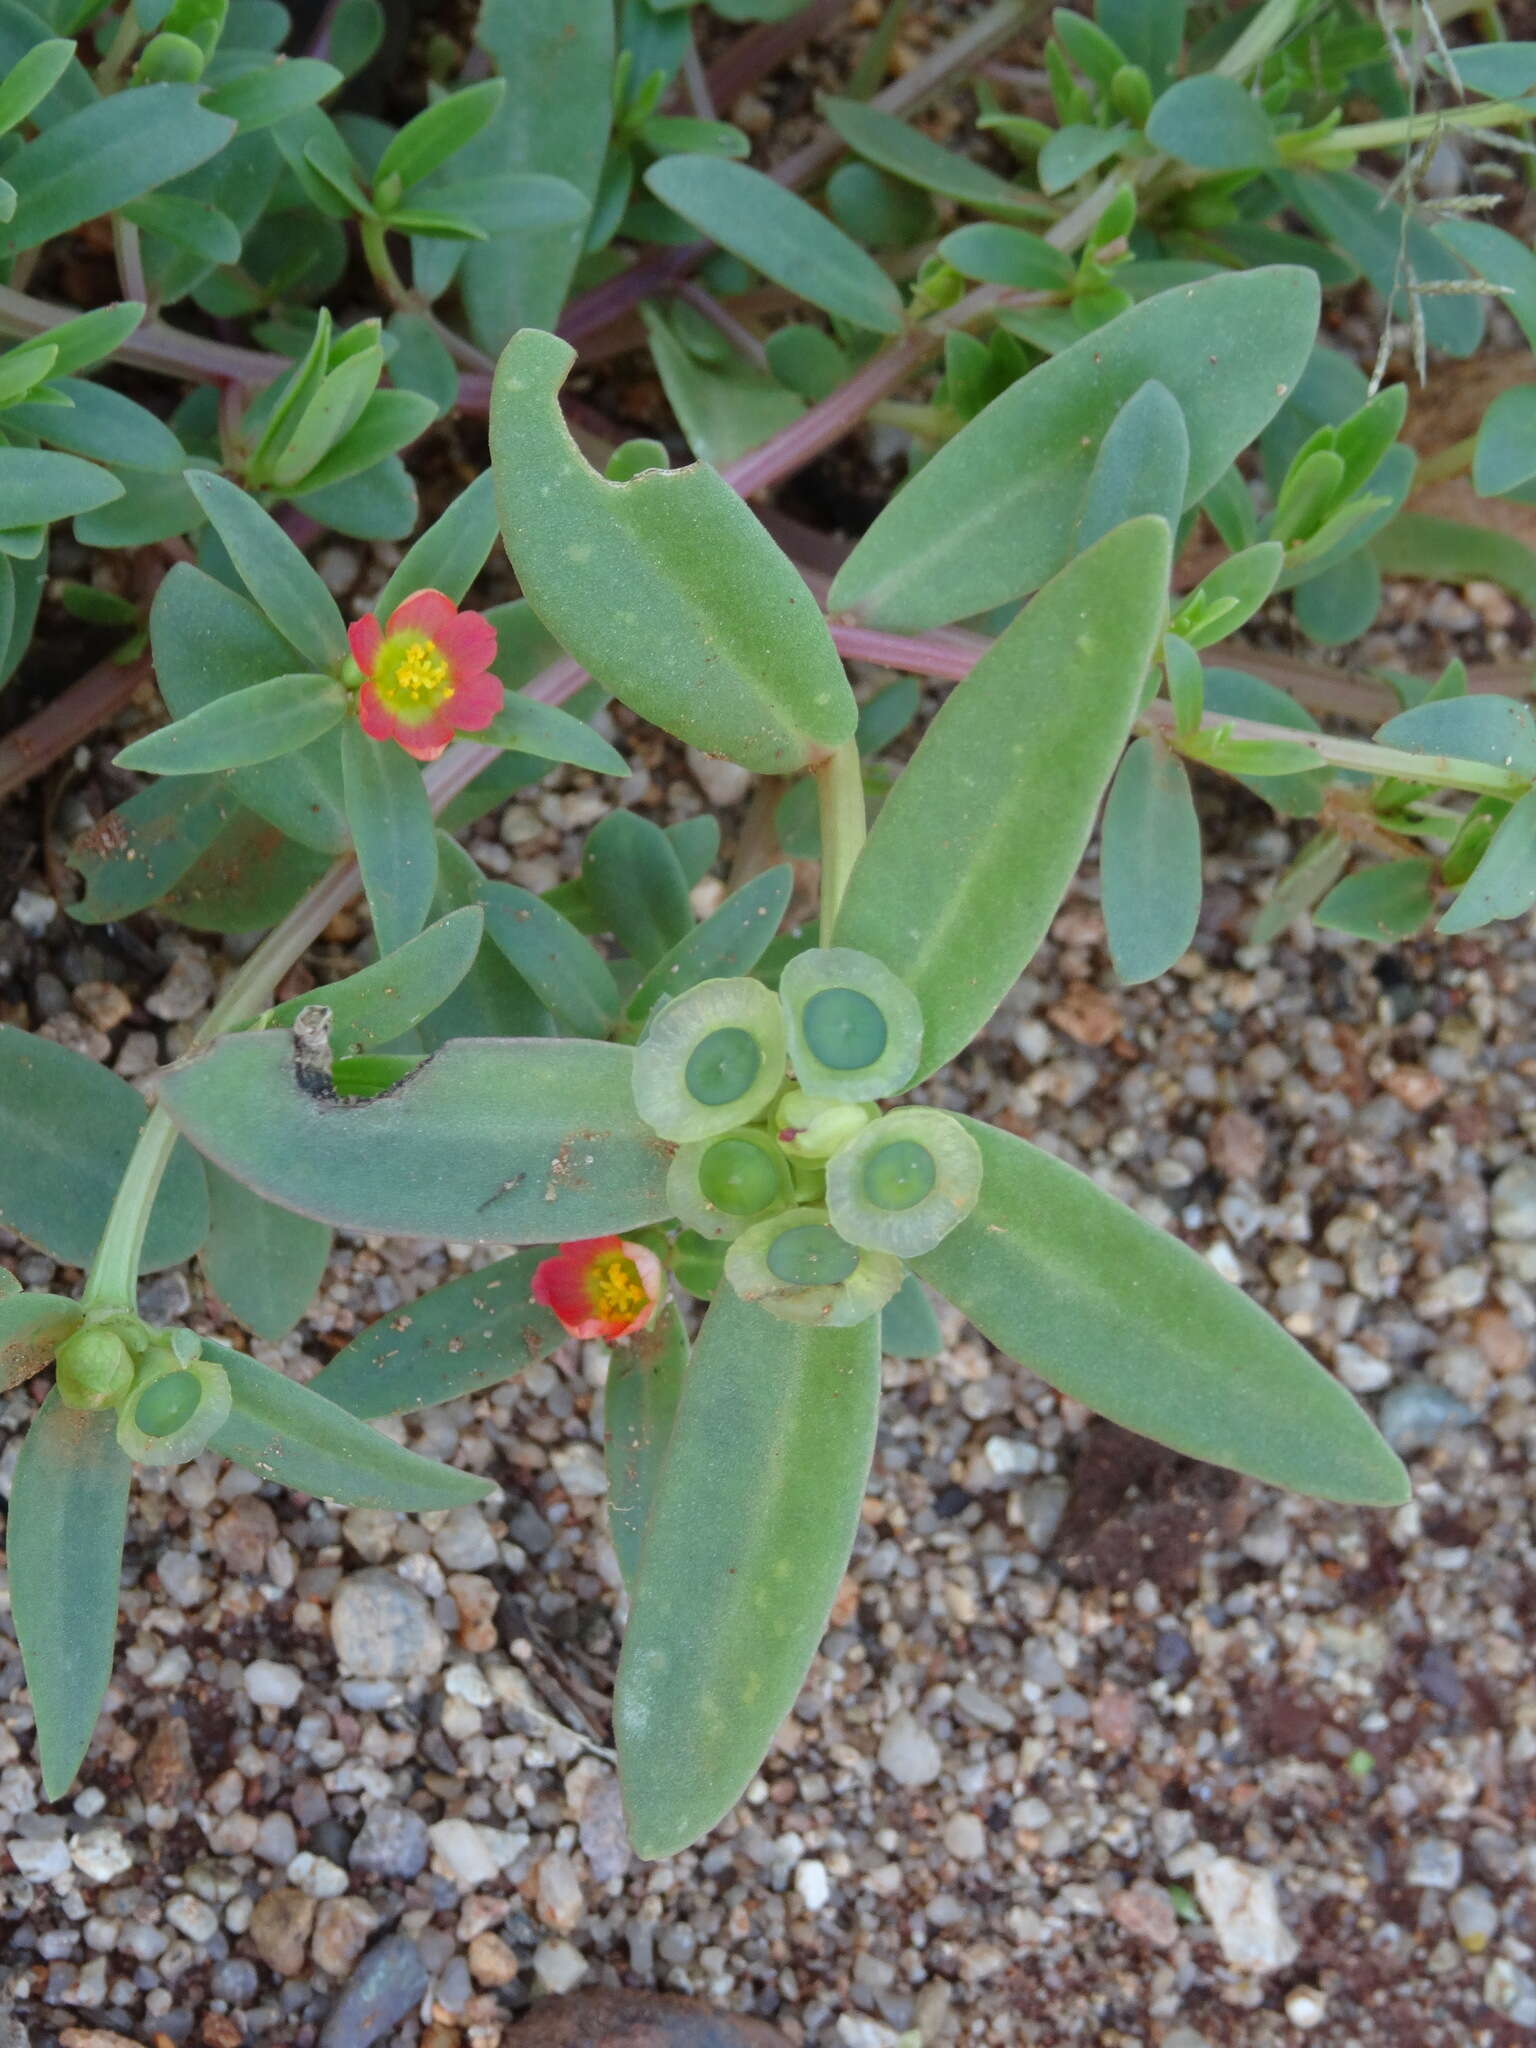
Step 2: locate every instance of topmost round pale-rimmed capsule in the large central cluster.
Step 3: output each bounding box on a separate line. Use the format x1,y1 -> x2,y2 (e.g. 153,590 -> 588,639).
778,946 -> 924,1102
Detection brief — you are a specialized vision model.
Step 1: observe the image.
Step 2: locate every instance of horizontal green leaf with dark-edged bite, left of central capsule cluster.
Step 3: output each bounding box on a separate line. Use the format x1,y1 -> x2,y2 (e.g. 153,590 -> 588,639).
154,1032 -> 672,1245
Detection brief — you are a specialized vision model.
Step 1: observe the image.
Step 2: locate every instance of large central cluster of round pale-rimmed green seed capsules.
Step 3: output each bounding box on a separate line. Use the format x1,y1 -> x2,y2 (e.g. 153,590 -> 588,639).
635,946 -> 981,1329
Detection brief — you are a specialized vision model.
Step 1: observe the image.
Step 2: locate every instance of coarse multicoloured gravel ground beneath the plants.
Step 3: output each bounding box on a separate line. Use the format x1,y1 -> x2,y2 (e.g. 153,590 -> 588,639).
0,643 -> 1536,2048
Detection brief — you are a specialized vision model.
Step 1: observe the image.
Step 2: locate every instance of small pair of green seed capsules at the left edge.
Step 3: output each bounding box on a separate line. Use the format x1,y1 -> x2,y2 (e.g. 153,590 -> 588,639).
55,1309 -> 231,1464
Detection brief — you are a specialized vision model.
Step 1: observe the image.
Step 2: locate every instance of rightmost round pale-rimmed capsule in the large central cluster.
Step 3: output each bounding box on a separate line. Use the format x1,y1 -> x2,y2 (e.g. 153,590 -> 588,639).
827,1108 -> 981,1260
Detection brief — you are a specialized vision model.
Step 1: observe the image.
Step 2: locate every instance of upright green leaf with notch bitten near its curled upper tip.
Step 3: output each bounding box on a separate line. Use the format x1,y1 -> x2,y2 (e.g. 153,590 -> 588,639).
492,327 -> 856,774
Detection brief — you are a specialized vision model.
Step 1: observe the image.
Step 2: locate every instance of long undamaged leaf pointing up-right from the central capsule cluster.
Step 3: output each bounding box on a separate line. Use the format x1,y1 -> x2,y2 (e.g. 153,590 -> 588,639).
836,518 -> 1169,1079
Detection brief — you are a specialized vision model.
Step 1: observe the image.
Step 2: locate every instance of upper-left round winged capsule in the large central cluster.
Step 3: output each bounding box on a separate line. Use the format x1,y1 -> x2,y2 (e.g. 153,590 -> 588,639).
635,975 -> 784,1145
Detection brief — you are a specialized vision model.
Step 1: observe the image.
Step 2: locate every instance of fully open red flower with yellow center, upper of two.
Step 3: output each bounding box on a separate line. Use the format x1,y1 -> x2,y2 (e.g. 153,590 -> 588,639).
346,590 -> 506,762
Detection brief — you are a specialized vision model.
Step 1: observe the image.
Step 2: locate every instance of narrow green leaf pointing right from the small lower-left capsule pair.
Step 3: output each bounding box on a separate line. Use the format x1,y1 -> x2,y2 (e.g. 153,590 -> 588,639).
201,1337 -> 492,1513
